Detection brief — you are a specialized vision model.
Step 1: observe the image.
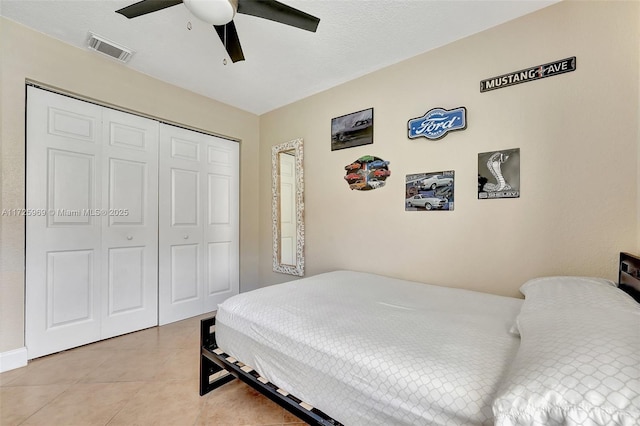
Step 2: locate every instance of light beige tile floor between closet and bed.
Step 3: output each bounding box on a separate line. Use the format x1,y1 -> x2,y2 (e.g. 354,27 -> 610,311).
0,315 -> 305,426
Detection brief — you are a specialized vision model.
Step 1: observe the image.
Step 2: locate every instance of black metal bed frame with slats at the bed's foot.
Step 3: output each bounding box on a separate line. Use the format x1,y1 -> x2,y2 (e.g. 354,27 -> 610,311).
200,316 -> 343,426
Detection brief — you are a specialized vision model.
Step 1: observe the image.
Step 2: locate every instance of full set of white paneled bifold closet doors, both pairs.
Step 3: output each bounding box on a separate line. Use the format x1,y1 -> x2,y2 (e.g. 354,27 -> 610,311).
26,86 -> 239,359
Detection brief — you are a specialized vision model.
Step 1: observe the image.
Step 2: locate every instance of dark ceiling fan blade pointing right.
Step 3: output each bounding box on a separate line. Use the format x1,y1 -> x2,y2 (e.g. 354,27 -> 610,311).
238,0 -> 320,32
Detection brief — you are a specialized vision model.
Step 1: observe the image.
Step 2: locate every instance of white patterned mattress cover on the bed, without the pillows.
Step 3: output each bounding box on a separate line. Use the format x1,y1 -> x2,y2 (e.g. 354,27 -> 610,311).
216,271 -> 522,426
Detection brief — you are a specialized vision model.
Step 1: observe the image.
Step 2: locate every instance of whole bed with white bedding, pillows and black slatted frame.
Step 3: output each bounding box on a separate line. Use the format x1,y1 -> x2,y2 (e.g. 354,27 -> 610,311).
200,260 -> 640,425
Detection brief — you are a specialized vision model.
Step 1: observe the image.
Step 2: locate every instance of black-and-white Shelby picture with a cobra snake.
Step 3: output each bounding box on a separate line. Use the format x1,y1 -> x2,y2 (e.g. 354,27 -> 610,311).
478,148 -> 520,200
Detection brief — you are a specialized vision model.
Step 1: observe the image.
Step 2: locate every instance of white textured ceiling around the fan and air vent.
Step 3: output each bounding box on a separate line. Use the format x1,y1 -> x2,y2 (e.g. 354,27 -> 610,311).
0,0 -> 559,114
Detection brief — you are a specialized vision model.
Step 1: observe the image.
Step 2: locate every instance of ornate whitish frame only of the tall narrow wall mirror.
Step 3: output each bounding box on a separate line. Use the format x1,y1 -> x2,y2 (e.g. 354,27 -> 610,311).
271,139 -> 304,277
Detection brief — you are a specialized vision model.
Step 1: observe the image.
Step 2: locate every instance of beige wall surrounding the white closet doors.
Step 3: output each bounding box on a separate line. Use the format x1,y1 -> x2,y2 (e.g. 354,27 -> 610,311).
0,18 -> 259,353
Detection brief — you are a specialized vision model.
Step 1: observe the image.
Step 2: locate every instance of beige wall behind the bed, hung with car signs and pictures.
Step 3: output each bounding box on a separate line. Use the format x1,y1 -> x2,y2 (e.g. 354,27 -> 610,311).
260,2 -> 640,296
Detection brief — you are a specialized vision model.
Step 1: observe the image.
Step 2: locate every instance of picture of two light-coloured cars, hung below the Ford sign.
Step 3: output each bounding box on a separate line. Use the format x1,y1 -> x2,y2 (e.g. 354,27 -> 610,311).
404,170 -> 455,211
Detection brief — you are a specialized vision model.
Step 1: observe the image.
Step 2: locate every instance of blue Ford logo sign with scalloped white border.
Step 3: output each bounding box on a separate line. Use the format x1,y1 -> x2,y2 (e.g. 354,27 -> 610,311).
409,107 -> 467,140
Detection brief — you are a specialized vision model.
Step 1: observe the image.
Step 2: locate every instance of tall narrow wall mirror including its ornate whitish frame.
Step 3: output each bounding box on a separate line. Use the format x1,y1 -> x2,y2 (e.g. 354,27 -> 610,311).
271,139 -> 304,277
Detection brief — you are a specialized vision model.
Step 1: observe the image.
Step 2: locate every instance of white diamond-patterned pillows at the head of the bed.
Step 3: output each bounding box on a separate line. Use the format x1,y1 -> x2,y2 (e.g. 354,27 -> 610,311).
493,277 -> 640,426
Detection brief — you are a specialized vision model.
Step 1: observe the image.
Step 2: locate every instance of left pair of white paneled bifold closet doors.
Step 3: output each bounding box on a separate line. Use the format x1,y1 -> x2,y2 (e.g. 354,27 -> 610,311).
25,87 -> 158,359
